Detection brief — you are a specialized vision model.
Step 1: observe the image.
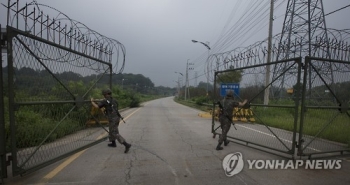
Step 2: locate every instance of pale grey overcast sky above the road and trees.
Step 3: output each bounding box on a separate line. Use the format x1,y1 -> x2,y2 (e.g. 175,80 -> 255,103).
0,0 -> 350,87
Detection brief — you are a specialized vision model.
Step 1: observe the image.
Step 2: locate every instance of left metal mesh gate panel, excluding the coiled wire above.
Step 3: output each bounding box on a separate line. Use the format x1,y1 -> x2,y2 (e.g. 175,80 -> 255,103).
5,27 -> 112,175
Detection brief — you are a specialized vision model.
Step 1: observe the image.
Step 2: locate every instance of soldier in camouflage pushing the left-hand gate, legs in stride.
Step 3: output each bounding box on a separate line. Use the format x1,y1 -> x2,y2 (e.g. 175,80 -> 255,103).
91,89 -> 131,153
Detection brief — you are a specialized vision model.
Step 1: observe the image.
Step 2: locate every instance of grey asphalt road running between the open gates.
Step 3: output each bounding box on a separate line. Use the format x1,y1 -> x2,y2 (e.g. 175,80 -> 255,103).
5,97 -> 350,185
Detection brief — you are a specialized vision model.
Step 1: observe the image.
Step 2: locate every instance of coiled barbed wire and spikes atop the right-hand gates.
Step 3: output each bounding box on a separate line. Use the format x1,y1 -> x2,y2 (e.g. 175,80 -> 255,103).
206,29 -> 350,81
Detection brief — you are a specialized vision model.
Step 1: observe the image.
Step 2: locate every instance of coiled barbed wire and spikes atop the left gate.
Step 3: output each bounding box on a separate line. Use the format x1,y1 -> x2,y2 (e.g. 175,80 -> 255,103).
2,0 -> 126,73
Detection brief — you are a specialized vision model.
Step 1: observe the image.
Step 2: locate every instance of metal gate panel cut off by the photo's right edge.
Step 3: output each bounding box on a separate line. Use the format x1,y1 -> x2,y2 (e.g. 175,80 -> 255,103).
298,57 -> 350,158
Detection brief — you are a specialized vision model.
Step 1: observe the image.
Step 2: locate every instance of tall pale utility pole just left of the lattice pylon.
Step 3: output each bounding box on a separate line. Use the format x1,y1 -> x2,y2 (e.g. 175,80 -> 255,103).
264,0 -> 274,105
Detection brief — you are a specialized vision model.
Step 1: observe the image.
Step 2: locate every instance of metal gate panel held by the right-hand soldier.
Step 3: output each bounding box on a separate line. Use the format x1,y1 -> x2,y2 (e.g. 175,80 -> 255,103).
212,58 -> 302,158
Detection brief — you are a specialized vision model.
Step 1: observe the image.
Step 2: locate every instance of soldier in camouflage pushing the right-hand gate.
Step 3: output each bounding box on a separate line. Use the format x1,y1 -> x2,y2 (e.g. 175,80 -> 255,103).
216,90 -> 247,150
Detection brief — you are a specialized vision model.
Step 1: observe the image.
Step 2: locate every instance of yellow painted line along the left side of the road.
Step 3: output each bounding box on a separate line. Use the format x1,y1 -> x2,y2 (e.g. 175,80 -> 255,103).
38,107 -> 141,185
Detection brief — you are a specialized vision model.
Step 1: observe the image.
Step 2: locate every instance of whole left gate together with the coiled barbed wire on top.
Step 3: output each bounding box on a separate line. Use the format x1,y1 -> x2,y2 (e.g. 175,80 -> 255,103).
0,0 -> 125,179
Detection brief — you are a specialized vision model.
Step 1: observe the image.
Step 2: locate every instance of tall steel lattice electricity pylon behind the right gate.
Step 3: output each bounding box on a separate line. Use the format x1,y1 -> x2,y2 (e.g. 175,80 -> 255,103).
274,0 -> 334,99
